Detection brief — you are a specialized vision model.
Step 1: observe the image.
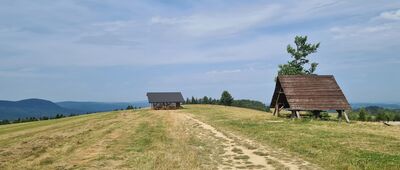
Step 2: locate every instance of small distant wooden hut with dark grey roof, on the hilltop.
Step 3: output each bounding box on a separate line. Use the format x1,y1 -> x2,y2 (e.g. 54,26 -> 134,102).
147,92 -> 185,110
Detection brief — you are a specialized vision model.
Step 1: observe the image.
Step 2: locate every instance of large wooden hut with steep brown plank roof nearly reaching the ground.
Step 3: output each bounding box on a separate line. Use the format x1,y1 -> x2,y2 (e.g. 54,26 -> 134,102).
270,75 -> 351,122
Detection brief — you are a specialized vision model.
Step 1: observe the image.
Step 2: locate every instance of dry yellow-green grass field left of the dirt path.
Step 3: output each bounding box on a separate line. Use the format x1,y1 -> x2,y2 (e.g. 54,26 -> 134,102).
0,110 -> 219,169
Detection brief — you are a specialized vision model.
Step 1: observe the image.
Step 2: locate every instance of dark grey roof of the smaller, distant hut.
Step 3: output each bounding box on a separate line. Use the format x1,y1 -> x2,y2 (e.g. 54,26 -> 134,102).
147,92 -> 185,103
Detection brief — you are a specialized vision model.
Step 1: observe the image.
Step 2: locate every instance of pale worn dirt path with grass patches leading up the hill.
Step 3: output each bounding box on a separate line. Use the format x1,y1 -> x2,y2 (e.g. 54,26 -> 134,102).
180,113 -> 319,169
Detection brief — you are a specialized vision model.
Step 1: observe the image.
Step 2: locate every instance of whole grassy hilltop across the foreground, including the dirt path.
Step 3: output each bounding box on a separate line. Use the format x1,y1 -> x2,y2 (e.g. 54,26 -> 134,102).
0,105 -> 400,169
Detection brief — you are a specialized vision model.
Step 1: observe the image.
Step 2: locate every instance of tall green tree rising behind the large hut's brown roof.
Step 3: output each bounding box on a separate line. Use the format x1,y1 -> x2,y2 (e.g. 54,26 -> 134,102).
278,36 -> 320,75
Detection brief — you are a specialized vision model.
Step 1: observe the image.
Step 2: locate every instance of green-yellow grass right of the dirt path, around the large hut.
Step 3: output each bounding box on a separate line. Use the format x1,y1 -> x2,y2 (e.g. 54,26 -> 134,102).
182,105 -> 400,169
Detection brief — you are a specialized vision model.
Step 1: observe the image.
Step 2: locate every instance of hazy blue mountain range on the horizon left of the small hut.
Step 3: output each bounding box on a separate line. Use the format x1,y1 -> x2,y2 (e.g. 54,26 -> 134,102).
0,99 -> 148,120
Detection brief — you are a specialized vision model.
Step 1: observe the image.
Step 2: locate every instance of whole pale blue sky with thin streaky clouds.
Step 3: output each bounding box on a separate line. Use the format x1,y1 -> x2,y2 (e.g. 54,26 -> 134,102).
0,0 -> 400,103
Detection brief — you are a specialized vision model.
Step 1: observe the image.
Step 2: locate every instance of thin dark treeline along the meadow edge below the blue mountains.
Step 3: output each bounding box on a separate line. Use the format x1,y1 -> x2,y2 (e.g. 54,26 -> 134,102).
0,105 -> 141,125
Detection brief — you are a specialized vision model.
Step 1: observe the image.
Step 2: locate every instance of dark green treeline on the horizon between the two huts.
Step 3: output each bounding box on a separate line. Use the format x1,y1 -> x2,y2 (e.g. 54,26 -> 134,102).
185,91 -> 269,111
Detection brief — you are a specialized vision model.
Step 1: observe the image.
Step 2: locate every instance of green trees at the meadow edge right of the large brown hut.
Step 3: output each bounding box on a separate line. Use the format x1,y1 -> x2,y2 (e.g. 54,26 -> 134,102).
349,106 -> 400,121
